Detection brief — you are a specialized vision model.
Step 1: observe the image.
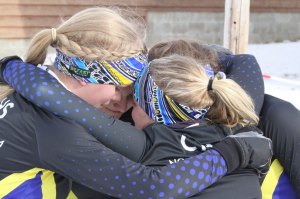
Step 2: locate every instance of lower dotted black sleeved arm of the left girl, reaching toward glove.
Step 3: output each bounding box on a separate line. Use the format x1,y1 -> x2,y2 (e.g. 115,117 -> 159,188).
37,115 -> 266,198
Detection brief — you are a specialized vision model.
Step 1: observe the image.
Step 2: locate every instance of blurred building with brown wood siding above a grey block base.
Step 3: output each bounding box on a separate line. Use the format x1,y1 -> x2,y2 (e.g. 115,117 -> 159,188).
0,0 -> 300,57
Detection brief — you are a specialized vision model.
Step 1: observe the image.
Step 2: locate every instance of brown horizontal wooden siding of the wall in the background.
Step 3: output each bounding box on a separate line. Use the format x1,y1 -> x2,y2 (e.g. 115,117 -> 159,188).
0,0 -> 300,39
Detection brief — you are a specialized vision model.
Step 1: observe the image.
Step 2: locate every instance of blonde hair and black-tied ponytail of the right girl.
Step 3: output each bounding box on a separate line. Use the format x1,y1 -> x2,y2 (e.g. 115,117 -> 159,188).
149,55 -> 258,127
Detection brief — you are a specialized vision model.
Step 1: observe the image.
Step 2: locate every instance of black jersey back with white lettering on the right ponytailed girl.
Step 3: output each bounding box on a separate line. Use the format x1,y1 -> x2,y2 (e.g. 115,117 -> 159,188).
141,120 -> 261,199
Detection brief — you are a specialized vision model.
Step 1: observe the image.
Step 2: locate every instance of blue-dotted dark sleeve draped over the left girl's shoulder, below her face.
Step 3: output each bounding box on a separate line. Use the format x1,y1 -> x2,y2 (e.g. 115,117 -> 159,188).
3,60 -> 146,161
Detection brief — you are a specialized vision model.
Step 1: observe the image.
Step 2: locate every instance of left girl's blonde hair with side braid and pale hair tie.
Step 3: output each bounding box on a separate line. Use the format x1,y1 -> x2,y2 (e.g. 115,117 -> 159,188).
26,7 -> 145,65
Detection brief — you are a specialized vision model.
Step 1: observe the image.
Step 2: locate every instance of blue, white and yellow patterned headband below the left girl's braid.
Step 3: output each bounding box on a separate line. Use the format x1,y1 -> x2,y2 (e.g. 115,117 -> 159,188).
54,50 -> 148,85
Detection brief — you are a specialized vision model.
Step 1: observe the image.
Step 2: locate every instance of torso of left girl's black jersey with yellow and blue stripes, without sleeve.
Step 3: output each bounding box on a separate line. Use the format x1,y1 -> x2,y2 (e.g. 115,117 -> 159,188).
0,93 -> 71,198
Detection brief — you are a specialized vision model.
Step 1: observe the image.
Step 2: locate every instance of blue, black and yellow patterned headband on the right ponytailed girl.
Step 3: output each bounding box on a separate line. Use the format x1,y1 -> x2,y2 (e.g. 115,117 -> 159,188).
134,65 -> 214,125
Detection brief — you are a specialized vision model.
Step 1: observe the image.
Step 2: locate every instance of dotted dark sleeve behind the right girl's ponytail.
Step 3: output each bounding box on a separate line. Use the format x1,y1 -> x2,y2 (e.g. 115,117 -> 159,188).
220,54 -> 265,114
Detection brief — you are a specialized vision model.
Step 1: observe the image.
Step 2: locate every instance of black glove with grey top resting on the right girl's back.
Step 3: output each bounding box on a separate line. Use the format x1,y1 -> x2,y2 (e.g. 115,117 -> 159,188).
213,131 -> 273,176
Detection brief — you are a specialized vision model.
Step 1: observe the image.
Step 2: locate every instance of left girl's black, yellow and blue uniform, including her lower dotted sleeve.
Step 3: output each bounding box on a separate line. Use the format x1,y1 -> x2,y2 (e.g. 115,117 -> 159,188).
0,93 -> 233,198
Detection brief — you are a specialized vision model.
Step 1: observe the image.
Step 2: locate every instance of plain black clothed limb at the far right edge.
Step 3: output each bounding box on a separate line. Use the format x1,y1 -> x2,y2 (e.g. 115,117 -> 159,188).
259,94 -> 300,196
